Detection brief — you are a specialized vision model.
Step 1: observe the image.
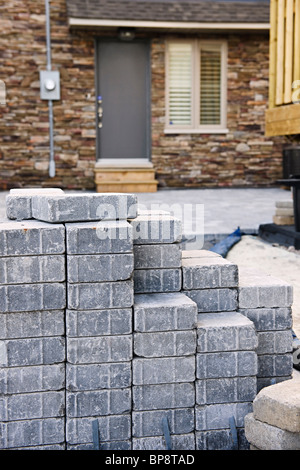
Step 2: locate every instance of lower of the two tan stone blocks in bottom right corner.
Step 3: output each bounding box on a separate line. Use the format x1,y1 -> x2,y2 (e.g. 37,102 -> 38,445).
245,413 -> 300,450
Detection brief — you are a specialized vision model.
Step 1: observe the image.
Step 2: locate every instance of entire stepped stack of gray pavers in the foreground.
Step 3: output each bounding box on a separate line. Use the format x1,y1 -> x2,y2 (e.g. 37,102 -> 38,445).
0,190 -> 292,450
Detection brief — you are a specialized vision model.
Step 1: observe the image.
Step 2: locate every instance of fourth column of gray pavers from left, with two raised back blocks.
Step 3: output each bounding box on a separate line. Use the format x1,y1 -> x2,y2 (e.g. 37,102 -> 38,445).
182,251 -> 257,450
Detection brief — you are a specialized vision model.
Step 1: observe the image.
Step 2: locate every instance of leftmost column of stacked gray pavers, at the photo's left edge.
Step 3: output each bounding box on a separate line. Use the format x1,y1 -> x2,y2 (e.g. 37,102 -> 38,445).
0,187 -> 66,449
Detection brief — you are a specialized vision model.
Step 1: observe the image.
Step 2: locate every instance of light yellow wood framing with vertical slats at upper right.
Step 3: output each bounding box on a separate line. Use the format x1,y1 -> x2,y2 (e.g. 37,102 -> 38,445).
266,0 -> 300,136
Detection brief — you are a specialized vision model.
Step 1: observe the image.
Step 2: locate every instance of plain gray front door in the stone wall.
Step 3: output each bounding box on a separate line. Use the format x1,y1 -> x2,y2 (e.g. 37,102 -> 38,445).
97,41 -> 150,160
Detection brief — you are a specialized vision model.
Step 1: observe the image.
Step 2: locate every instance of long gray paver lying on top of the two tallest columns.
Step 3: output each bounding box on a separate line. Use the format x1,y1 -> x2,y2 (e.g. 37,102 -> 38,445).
32,193 -> 137,223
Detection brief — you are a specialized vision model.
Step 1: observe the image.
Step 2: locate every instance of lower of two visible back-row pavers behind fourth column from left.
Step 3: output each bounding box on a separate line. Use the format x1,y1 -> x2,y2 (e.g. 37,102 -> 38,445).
184,288 -> 238,313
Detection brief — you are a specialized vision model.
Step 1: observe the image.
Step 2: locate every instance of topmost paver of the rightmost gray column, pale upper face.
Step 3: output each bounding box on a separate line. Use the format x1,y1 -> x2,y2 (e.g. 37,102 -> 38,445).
239,269 -> 293,309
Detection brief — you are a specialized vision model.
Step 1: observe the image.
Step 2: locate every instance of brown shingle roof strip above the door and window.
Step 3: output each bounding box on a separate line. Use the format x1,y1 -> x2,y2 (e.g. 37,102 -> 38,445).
67,0 -> 270,23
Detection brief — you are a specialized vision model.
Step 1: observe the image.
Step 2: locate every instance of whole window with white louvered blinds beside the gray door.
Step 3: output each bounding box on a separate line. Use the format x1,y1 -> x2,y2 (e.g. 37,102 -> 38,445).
165,40 -> 227,133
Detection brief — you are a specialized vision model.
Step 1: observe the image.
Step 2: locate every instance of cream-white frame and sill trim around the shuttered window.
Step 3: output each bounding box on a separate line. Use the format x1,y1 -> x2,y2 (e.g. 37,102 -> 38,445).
164,39 -> 229,134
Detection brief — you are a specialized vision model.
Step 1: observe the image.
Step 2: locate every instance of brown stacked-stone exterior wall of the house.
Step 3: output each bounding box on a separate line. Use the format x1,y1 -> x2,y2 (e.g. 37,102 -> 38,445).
0,0 -> 285,190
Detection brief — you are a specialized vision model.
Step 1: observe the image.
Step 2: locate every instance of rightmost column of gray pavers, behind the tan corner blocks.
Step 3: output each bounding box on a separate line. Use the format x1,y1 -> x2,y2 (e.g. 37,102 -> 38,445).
239,268 -> 293,391
